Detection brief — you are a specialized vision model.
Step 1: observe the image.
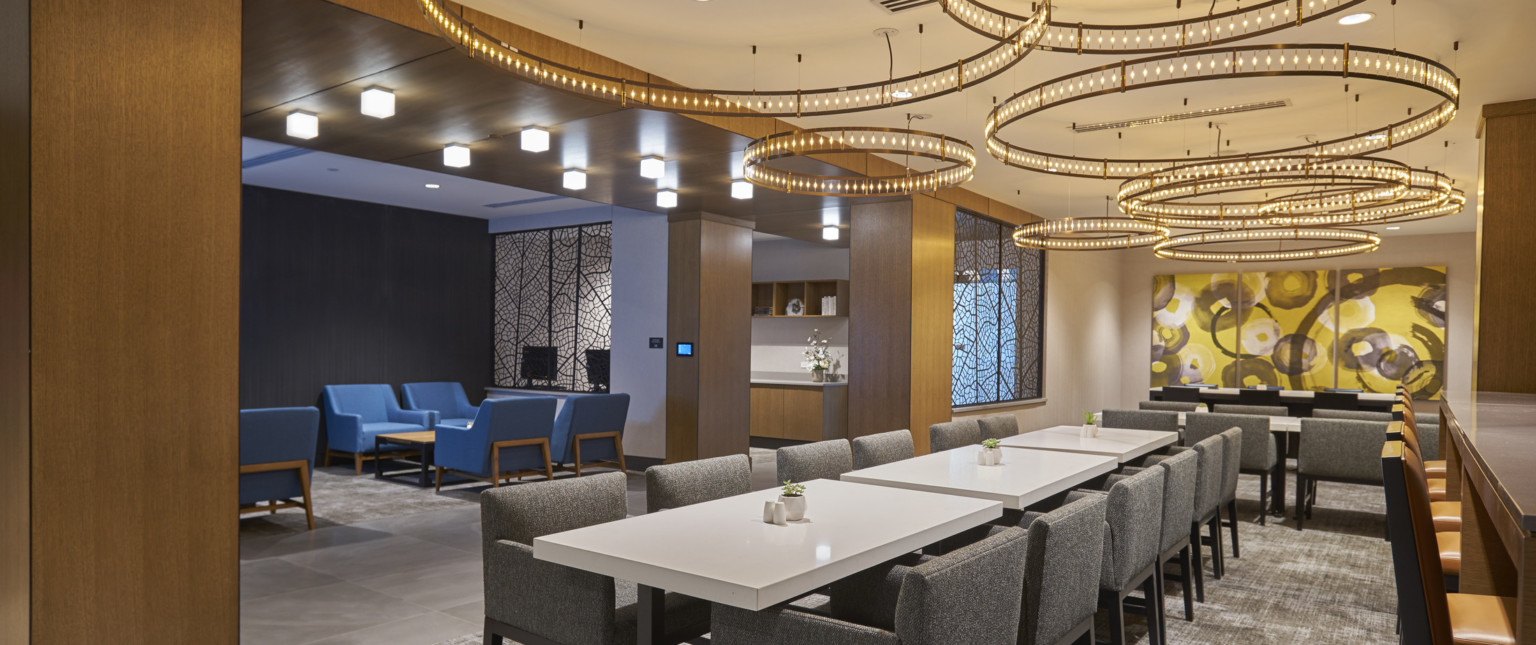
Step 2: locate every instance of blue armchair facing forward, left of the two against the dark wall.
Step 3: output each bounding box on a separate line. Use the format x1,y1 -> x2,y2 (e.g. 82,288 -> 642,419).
324,384 -> 436,475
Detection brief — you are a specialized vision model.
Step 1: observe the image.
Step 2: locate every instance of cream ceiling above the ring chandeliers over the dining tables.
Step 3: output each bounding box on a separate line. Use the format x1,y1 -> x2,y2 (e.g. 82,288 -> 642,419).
465,0 -> 1536,235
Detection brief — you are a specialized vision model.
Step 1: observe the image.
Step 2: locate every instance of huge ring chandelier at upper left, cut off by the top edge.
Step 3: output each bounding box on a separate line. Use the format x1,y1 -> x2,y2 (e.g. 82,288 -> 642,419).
418,0 -> 1049,117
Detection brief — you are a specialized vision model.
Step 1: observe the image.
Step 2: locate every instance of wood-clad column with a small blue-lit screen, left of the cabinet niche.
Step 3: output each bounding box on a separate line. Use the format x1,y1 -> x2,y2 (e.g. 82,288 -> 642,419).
667,213 -> 753,462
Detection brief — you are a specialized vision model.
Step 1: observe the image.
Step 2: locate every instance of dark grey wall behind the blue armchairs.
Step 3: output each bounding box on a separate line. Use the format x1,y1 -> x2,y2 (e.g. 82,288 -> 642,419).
240,186 -> 492,426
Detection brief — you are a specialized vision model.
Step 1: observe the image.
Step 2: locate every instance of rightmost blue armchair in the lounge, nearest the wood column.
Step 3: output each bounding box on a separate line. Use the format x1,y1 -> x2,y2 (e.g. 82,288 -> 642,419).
550,395 -> 630,478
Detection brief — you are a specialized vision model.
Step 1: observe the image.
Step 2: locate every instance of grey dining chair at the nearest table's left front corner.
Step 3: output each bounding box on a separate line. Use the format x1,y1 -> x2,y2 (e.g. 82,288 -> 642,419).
481,473 -> 710,645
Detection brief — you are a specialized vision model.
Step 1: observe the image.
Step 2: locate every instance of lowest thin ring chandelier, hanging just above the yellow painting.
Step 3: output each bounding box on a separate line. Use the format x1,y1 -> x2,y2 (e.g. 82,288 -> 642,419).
1152,229 -> 1381,263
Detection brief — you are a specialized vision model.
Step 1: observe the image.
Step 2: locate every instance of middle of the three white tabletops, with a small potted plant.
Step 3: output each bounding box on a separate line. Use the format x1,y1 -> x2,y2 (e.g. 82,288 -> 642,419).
843,445 -> 1117,508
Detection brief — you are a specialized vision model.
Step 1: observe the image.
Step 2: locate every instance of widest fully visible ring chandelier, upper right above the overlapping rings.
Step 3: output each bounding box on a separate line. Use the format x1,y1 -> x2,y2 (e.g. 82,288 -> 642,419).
986,45 -> 1461,180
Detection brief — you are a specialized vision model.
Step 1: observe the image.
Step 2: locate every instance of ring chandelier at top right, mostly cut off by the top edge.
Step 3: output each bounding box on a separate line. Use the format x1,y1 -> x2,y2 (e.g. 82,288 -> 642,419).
942,0 -> 1366,54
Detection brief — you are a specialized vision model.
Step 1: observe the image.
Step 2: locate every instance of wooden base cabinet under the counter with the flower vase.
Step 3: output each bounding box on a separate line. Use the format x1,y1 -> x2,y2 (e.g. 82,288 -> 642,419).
751,382 -> 848,441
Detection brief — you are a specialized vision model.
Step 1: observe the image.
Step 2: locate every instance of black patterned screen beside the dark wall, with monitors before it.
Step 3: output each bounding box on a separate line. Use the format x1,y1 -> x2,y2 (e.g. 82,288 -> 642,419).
493,223 -> 613,392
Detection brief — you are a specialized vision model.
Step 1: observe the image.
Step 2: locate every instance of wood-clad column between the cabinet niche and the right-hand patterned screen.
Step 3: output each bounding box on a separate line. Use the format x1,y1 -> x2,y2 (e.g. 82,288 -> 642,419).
848,195 -> 955,453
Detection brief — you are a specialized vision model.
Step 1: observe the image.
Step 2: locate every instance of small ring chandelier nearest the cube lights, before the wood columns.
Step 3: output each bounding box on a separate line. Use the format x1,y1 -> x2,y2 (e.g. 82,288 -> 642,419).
742,127 -> 975,197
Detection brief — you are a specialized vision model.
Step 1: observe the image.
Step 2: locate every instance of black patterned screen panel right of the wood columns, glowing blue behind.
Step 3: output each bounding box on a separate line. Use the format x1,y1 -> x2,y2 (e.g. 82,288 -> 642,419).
952,210 -> 1046,407
